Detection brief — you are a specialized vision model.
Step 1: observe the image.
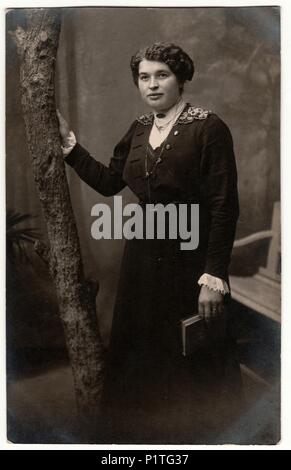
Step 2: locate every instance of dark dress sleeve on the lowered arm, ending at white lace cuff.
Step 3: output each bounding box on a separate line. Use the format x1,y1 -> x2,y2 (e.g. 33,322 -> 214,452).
200,115 -> 239,280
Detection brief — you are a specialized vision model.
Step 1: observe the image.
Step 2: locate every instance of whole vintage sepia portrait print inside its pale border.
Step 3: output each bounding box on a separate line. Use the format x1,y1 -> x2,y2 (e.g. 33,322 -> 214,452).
6,6 -> 281,446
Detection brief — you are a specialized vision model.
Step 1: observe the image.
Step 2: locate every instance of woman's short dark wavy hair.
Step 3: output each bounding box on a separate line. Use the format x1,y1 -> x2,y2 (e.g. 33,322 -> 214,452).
130,42 -> 195,90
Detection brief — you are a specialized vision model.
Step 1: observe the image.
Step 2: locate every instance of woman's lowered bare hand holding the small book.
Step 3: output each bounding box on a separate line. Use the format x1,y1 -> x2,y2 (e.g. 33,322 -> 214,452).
198,286 -> 224,322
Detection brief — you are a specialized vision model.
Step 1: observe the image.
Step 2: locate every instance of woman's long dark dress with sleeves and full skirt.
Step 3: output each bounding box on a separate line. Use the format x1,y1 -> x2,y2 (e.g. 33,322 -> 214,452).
67,107 -> 244,444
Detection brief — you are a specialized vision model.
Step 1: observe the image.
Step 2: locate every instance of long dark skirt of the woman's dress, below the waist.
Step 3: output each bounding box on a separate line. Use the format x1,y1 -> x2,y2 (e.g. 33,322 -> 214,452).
101,239 -> 241,444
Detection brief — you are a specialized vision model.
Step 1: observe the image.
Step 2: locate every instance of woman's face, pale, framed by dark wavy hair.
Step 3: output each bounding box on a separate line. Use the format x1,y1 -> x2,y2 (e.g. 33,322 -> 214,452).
138,59 -> 180,111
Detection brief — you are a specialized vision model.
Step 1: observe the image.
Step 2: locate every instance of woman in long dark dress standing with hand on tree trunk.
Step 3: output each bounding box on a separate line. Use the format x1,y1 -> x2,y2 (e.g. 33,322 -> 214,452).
58,43 -> 240,444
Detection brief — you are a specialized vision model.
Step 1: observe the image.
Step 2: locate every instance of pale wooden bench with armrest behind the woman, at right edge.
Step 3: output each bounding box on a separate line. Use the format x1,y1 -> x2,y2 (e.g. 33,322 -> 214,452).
230,202 -> 281,322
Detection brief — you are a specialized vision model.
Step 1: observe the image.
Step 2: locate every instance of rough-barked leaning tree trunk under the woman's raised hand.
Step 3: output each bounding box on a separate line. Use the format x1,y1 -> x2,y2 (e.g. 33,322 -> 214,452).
13,8 -> 104,417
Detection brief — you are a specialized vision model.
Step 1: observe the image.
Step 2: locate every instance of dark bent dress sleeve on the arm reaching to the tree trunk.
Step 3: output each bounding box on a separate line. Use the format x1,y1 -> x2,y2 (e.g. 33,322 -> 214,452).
65,121 -> 137,196
